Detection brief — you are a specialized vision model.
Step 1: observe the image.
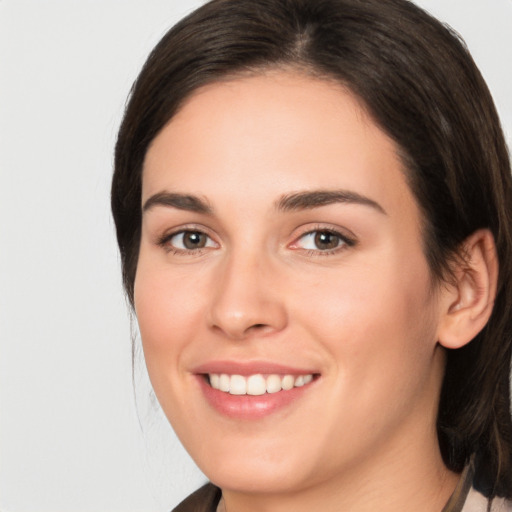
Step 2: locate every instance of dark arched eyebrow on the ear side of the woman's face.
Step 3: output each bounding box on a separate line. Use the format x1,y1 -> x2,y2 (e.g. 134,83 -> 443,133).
276,190 -> 387,215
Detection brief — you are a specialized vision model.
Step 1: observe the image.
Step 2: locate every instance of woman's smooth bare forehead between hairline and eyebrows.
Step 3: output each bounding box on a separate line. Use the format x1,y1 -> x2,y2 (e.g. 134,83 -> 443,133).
143,72 -> 414,222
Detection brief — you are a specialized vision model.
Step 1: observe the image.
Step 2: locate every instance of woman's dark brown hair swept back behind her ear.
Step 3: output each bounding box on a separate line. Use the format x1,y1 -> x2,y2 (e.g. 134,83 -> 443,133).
112,0 -> 512,498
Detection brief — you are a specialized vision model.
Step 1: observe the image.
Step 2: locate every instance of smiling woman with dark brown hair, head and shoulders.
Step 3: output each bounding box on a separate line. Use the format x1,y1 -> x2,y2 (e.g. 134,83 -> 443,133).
112,0 -> 512,512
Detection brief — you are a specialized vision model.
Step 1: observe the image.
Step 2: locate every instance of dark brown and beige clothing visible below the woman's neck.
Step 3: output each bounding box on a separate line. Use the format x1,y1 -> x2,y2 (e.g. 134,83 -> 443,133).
172,464 -> 512,512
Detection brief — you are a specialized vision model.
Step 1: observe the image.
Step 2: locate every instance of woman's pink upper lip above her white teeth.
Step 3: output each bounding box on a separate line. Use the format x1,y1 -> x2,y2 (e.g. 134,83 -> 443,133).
192,361 -> 319,376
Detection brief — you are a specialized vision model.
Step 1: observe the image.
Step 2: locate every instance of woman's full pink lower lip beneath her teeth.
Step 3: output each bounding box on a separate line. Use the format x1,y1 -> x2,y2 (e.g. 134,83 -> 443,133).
197,375 -> 316,420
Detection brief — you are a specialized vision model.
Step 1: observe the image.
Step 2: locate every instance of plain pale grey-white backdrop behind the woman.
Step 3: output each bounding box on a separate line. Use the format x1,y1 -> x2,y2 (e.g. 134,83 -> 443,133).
0,0 -> 512,512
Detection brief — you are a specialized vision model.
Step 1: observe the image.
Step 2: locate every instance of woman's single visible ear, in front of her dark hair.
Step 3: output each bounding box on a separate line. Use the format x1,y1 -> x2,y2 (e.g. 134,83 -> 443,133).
437,229 -> 498,349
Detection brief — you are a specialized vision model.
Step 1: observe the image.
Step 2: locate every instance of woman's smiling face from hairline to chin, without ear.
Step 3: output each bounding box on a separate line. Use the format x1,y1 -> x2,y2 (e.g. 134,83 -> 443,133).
135,72 -> 448,492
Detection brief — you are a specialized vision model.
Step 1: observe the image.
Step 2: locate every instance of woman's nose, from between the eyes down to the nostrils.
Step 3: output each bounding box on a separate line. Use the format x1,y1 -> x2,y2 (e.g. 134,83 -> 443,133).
208,248 -> 288,340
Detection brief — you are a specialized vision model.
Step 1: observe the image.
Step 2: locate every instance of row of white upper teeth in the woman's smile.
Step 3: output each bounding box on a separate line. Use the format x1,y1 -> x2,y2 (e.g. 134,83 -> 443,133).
209,373 -> 313,395
